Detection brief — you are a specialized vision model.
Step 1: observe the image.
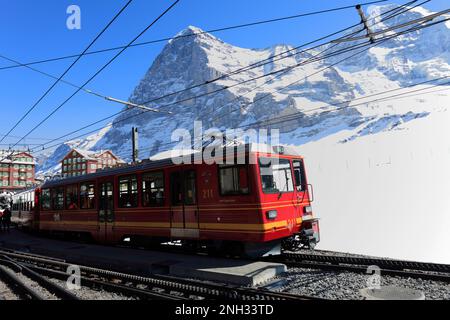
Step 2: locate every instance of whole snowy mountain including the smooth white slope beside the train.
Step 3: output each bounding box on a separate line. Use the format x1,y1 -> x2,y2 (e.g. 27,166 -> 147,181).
36,5 -> 450,263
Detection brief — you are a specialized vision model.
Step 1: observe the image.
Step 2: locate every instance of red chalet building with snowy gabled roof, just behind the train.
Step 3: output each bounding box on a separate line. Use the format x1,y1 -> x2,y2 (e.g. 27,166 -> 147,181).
61,148 -> 125,177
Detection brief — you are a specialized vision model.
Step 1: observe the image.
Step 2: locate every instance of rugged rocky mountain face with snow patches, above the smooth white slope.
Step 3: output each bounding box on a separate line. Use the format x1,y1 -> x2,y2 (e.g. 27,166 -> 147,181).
40,5 -> 450,172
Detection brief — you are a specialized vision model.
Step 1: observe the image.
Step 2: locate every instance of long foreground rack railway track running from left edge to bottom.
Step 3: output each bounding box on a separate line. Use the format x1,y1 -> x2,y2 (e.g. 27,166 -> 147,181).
0,250 -> 321,301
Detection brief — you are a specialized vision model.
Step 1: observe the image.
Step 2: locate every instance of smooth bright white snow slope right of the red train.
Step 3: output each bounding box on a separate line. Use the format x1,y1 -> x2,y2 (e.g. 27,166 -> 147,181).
303,92 -> 450,263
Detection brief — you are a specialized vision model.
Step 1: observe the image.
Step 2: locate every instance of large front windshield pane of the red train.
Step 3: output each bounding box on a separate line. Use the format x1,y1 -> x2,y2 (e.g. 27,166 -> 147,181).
259,158 -> 294,193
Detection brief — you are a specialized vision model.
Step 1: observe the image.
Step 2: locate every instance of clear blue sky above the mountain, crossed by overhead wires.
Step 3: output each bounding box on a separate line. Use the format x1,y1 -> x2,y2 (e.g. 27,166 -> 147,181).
0,0 -> 448,152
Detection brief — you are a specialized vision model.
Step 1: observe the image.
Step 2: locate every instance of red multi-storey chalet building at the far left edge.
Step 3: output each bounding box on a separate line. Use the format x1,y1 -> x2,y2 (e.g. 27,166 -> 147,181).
0,150 -> 36,191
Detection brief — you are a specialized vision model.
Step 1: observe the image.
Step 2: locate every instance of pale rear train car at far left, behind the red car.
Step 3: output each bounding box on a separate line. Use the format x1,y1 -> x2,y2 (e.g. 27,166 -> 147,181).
11,188 -> 35,228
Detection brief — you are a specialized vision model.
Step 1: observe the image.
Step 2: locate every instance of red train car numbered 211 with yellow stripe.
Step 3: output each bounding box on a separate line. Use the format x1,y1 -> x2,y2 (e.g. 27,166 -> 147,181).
10,144 -> 319,256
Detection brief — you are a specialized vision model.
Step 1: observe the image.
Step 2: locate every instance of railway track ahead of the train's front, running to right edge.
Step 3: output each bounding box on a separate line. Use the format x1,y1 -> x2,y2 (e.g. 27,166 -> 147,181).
266,253 -> 450,283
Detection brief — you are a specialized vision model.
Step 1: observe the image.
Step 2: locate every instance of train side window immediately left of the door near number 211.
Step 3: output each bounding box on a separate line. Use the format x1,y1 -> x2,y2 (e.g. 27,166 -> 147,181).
142,172 -> 164,207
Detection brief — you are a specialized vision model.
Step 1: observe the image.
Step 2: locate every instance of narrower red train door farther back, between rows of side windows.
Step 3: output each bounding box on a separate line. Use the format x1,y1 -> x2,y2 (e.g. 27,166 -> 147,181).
98,180 -> 115,242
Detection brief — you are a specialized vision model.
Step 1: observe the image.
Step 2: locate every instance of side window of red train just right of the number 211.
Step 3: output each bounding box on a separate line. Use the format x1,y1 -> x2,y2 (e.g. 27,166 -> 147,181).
219,165 -> 249,195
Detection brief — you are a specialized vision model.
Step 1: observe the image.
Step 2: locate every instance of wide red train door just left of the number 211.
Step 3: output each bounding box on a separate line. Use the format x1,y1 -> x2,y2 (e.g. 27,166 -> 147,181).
170,167 -> 199,238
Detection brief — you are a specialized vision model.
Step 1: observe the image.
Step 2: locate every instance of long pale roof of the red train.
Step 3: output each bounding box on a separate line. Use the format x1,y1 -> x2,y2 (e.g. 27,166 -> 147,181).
41,143 -> 301,188
